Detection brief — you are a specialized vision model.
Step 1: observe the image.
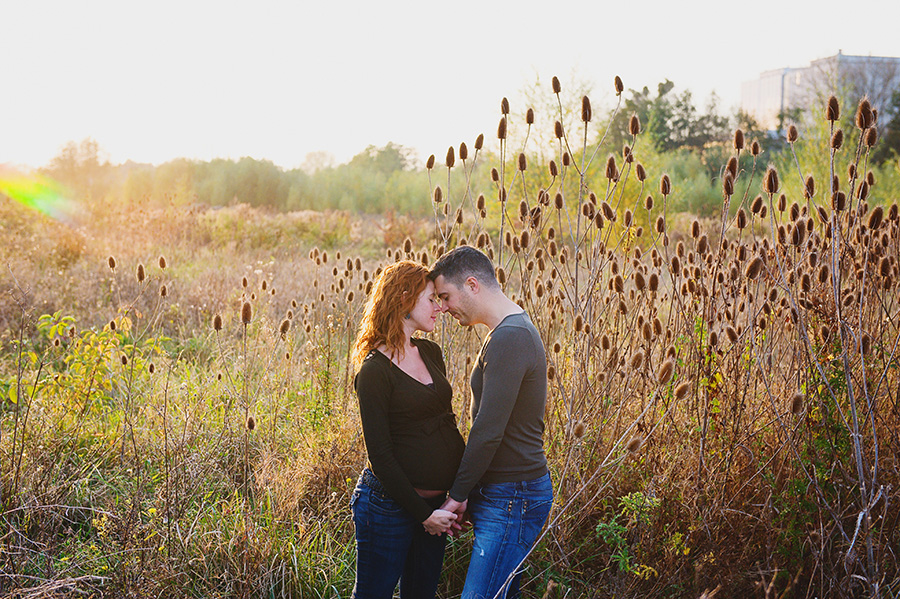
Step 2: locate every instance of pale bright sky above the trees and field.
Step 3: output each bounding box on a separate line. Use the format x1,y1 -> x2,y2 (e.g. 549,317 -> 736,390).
0,0 -> 900,169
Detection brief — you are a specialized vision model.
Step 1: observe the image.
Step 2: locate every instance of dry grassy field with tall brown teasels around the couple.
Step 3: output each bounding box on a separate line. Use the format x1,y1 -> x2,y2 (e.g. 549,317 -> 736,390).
0,86 -> 900,598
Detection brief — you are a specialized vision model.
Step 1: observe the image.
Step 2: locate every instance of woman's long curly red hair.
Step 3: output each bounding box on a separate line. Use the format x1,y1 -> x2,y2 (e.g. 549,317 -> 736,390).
353,260 -> 428,366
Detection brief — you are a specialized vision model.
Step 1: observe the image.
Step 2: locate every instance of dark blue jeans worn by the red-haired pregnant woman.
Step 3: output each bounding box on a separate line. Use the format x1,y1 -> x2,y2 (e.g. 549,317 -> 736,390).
350,471 -> 447,599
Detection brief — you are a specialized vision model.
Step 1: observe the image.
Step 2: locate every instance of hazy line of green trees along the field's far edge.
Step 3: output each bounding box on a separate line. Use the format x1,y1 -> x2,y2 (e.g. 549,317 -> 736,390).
42,80 -> 900,216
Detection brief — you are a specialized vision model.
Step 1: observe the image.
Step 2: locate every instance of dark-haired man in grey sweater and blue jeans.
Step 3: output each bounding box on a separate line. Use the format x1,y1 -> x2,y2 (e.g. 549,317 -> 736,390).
428,246 -> 553,599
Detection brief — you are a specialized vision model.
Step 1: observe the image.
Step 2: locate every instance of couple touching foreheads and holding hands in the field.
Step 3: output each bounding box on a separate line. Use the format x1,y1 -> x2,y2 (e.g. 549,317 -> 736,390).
351,246 -> 553,599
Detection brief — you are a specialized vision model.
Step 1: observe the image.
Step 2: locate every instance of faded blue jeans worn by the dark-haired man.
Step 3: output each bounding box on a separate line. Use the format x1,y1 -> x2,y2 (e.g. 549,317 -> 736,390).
462,474 -> 553,599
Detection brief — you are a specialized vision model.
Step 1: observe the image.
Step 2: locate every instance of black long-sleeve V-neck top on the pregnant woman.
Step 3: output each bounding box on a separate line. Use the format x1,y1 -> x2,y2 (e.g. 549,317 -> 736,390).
354,339 -> 465,522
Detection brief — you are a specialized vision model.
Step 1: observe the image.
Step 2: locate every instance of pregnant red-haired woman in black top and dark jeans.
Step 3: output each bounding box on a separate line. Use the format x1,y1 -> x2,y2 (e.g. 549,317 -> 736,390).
351,261 -> 465,599
